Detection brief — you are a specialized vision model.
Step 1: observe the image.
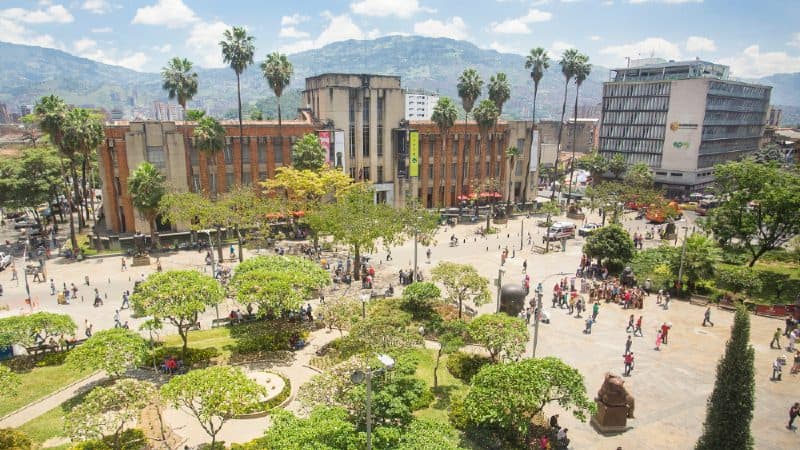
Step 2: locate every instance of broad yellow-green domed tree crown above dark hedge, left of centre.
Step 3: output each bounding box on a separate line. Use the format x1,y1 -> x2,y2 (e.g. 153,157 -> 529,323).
231,256 -> 331,315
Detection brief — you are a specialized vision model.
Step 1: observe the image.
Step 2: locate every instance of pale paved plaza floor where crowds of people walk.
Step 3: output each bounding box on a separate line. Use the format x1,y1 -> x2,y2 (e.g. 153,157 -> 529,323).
0,209 -> 800,450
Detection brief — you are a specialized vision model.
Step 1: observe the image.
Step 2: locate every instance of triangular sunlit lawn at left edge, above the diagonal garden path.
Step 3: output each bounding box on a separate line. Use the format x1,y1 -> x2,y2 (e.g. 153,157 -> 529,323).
0,364 -> 91,416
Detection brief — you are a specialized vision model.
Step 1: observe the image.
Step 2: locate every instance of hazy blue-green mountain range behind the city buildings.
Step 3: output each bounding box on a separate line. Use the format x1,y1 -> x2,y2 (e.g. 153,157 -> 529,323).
0,36 -> 800,123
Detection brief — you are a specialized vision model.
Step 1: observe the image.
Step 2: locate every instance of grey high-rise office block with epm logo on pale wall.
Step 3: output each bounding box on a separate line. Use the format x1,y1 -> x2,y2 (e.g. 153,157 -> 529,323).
599,58 -> 772,195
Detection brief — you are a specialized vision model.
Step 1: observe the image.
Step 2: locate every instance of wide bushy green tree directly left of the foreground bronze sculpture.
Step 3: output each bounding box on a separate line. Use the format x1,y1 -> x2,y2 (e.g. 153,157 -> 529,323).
463,357 -> 596,443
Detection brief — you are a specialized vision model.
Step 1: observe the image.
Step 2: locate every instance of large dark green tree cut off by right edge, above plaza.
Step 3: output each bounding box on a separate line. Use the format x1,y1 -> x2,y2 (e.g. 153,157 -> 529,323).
708,160 -> 800,267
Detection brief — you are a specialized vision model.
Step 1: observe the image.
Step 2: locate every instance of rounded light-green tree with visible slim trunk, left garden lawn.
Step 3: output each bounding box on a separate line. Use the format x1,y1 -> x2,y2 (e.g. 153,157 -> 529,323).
131,270 -> 225,360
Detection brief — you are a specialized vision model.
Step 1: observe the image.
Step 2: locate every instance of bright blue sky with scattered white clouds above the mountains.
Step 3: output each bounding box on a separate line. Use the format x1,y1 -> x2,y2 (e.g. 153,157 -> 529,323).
0,0 -> 800,77
